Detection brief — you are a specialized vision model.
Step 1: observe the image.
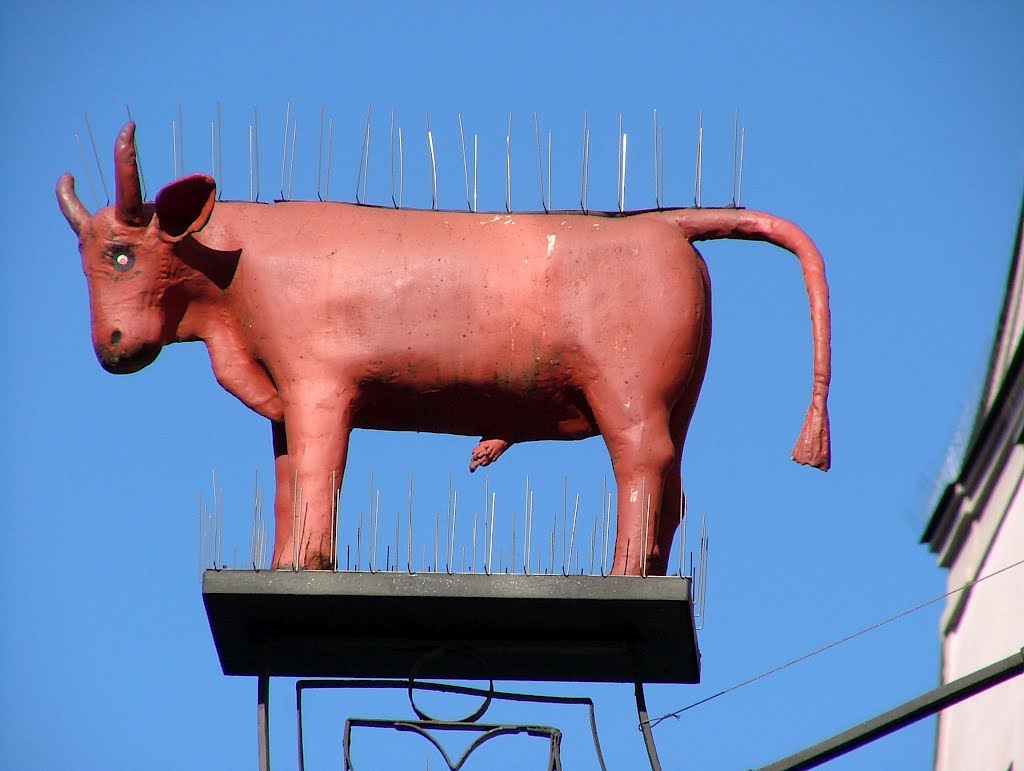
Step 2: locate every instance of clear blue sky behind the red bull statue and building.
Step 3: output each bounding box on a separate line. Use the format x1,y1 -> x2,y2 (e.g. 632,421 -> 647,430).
0,1 -> 1024,769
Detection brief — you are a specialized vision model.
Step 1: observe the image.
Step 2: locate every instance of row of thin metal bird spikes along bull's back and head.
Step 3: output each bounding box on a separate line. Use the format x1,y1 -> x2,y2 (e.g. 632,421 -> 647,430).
75,102 -> 746,214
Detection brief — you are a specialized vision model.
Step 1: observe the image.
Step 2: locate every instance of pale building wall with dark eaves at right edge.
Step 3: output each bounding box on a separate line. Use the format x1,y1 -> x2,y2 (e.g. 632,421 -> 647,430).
922,195 -> 1024,771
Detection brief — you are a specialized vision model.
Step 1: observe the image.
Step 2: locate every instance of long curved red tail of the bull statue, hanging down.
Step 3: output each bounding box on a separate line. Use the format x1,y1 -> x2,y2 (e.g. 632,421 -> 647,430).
655,209 -> 831,471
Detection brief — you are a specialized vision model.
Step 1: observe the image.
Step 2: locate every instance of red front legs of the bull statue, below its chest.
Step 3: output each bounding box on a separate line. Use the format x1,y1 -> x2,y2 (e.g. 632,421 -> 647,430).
273,389 -> 352,570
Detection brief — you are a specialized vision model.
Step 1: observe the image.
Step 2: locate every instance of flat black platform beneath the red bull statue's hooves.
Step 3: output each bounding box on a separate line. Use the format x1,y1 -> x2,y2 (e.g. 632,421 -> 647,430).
203,570 -> 700,683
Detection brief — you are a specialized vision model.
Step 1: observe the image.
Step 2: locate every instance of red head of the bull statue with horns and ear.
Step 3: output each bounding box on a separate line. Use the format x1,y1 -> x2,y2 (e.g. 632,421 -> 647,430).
56,123 -> 216,374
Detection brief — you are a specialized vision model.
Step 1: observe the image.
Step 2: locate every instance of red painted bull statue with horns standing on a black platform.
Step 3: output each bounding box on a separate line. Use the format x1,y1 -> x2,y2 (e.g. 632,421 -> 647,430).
56,123 -> 830,575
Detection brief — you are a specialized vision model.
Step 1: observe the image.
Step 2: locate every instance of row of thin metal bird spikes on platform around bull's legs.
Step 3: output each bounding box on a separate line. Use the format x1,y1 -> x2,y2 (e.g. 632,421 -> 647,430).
199,471 -> 708,617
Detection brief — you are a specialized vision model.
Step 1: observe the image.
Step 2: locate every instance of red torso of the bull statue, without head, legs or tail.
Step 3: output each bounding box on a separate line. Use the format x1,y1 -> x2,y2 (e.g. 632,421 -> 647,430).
207,203 -> 707,441
